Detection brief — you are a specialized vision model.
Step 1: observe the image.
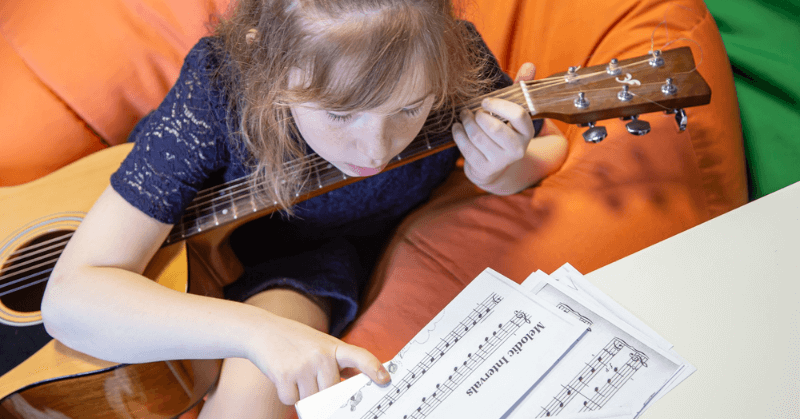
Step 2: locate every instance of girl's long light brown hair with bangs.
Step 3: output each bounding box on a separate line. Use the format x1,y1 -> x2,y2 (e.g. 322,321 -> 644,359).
215,0 -> 488,212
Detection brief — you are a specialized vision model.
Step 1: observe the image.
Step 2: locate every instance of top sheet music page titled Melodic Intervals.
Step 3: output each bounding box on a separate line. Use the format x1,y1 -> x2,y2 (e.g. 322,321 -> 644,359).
296,269 -> 587,419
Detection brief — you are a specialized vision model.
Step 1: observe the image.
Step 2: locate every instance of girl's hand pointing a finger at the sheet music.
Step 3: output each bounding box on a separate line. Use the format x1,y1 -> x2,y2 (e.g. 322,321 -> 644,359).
249,313 -> 391,405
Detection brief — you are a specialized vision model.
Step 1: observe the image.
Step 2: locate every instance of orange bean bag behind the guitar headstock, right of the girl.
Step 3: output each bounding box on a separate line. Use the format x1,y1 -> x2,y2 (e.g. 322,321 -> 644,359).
345,0 -> 747,360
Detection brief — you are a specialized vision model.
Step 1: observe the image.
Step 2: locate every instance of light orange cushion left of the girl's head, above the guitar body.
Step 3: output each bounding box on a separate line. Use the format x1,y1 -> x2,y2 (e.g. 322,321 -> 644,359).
0,0 -> 227,185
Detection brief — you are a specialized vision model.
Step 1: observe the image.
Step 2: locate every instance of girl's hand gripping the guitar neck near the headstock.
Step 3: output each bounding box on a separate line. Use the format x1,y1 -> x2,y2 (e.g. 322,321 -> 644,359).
453,63 -> 535,193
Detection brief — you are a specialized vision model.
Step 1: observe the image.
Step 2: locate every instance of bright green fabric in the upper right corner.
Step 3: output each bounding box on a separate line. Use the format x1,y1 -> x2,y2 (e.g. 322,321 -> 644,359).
706,0 -> 800,199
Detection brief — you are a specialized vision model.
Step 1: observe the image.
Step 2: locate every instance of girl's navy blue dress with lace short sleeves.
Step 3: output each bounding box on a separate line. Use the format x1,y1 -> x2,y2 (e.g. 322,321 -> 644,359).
106,27 -> 532,336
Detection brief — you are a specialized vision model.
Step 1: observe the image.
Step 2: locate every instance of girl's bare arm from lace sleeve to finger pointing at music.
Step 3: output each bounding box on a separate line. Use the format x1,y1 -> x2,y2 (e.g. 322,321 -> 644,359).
42,187 -> 388,404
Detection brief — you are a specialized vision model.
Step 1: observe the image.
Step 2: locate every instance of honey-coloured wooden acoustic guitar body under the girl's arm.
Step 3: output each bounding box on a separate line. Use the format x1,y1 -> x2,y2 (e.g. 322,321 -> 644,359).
0,144 -> 225,419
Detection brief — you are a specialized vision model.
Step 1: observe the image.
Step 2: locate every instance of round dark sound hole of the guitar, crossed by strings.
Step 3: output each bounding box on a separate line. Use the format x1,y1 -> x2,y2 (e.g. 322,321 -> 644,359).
0,230 -> 73,313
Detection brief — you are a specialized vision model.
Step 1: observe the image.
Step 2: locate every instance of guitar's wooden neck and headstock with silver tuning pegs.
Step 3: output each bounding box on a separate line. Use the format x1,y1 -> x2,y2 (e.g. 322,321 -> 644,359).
165,47 -> 711,244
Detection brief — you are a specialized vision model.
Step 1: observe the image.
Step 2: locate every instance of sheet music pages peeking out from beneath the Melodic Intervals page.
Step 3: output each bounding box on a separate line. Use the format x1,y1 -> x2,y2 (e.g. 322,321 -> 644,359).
507,275 -> 683,418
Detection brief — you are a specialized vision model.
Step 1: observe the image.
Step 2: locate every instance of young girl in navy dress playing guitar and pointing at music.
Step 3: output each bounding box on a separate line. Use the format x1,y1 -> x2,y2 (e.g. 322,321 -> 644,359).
42,0 -> 566,418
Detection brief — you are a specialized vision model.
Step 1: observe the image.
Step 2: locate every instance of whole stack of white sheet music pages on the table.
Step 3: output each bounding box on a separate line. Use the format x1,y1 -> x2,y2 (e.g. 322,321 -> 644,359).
296,265 -> 695,419
